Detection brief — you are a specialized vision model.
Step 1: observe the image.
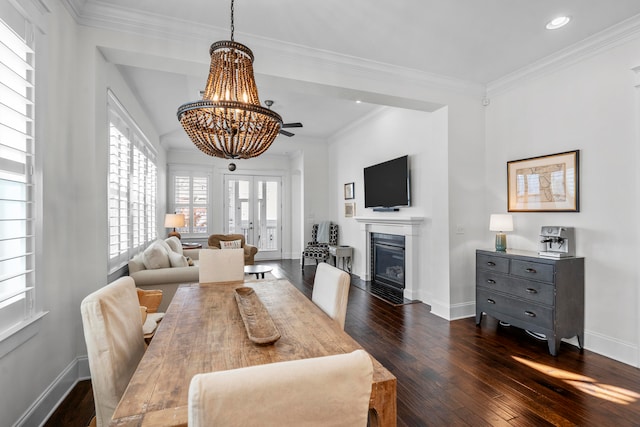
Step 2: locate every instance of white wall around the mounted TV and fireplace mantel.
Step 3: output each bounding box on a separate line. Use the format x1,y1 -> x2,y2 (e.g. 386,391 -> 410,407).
329,107 -> 438,303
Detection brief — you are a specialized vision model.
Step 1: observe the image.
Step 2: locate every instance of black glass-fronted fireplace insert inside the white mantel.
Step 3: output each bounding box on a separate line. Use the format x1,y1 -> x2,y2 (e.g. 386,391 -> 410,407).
371,233 -> 405,292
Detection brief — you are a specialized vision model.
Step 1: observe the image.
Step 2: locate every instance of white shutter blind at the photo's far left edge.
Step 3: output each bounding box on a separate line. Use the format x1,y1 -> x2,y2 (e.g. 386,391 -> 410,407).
0,20 -> 35,339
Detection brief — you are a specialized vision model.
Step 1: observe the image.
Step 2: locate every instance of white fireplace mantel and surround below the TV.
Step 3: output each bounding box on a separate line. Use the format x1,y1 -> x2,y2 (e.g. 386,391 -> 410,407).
354,216 -> 425,299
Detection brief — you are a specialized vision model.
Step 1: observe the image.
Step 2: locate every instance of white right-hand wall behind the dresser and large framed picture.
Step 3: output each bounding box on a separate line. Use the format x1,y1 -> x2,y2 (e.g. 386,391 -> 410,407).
485,37 -> 640,366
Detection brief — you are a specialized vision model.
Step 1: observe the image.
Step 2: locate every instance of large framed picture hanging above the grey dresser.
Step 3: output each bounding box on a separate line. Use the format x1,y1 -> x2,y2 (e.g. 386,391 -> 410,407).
507,150 -> 580,212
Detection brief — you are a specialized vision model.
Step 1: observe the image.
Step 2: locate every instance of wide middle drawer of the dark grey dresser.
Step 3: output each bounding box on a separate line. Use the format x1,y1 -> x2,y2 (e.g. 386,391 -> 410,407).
476,270 -> 555,306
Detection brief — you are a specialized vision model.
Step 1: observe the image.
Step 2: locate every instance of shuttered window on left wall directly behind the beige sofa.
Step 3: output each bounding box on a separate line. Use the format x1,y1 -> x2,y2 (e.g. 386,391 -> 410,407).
108,92 -> 158,272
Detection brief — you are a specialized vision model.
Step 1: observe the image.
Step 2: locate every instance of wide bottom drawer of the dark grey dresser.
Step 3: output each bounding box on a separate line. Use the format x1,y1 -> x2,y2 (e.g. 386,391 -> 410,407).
476,288 -> 553,329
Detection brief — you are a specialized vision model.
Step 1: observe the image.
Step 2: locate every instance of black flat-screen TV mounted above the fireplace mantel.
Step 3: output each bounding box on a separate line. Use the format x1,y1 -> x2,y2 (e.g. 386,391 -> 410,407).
364,156 -> 411,211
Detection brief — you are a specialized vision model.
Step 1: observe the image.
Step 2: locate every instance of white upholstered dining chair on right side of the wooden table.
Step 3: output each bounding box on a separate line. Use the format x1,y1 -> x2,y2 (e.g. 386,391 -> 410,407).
311,262 -> 351,329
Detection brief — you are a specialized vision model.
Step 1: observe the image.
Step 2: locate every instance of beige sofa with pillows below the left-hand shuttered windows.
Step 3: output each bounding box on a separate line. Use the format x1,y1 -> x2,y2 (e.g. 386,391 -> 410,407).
129,237 -> 200,312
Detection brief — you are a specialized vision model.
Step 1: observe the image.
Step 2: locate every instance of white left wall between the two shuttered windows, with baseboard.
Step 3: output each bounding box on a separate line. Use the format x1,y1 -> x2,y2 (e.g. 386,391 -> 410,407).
0,1 -> 164,425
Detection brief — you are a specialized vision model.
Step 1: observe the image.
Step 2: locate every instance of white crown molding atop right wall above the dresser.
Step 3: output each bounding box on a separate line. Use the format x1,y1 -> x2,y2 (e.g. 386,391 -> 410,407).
487,15 -> 640,98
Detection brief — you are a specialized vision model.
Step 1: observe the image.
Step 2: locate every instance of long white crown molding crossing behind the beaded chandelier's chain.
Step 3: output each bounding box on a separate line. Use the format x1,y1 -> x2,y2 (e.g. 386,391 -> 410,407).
62,0 -> 485,96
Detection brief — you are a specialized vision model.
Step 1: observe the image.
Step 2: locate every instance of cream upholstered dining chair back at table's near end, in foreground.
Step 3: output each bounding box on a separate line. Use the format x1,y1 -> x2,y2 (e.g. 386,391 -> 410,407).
188,350 -> 373,427
